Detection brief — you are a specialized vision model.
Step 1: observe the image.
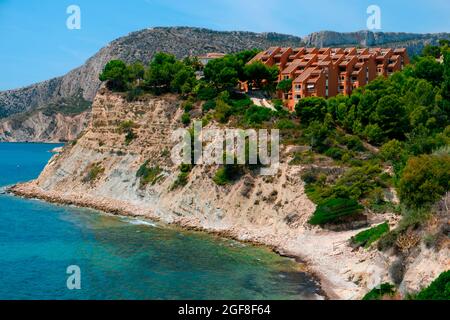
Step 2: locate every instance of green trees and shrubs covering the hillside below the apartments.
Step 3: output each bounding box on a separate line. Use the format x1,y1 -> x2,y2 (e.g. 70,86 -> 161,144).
96,41 -> 450,298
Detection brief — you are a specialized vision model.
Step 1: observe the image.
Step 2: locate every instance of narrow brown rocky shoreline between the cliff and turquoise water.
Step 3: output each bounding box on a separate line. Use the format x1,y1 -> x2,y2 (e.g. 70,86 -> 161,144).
4,182 -> 330,300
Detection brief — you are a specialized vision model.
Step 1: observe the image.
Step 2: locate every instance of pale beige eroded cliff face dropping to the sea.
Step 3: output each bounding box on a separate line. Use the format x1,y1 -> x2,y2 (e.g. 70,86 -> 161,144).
13,89 -> 448,299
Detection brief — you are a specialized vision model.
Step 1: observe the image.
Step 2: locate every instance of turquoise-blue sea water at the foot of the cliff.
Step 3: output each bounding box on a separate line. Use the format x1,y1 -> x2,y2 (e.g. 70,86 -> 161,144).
0,143 -> 318,299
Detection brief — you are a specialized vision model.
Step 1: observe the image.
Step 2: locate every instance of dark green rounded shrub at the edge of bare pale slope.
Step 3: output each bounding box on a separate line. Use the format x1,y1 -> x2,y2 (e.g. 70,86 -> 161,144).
309,198 -> 363,225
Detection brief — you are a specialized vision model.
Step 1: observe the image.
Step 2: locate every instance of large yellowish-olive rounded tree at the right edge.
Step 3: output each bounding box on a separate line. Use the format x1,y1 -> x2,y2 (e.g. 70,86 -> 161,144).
399,154 -> 450,208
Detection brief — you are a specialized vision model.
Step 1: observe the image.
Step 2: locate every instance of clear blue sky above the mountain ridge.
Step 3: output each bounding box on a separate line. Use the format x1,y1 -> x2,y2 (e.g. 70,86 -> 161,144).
0,0 -> 450,90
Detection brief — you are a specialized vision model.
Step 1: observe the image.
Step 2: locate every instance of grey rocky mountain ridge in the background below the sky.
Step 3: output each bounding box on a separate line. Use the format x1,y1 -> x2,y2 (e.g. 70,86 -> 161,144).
0,27 -> 450,141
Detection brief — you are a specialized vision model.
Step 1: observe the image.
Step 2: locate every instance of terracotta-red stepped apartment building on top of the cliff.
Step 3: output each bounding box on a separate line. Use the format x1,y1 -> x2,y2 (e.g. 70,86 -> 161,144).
249,47 -> 409,110
